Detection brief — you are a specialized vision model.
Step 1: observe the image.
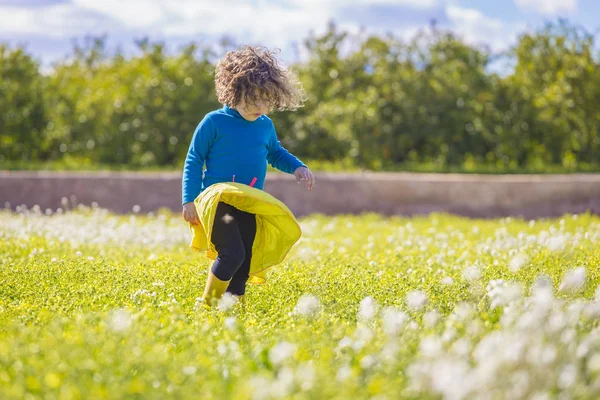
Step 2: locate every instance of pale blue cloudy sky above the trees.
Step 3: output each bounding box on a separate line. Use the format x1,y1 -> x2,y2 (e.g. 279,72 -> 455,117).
0,0 -> 600,65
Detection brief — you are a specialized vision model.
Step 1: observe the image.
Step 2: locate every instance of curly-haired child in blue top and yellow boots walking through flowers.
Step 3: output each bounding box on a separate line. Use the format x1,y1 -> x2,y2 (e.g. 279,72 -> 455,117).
182,46 -> 315,305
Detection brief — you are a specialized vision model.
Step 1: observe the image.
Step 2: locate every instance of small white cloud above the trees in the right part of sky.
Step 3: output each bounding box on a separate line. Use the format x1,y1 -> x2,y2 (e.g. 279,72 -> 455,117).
446,5 -> 525,51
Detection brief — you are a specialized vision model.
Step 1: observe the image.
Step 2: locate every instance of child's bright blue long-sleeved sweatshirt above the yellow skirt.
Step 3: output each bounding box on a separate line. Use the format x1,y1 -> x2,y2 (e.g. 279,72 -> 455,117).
182,106 -> 305,204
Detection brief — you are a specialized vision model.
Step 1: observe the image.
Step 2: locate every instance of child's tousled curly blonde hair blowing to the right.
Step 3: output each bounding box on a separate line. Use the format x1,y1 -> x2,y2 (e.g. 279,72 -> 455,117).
215,46 -> 306,111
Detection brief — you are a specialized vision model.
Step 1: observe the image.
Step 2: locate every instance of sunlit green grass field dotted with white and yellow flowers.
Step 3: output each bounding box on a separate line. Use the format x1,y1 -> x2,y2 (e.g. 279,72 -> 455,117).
0,209 -> 600,400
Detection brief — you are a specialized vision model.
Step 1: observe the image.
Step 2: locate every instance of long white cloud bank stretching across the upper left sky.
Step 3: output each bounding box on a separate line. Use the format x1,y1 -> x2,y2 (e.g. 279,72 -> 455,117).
0,0 -> 332,47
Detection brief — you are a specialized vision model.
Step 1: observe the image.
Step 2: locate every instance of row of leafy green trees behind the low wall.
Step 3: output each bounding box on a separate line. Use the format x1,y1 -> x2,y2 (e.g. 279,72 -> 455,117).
0,21 -> 600,170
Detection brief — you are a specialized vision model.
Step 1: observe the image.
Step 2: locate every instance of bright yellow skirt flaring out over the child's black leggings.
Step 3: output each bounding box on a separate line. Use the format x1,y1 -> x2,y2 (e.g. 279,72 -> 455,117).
189,182 -> 302,283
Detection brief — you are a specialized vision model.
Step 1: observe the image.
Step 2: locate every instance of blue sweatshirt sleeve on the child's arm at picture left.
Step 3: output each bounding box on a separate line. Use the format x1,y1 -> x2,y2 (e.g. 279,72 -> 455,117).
181,115 -> 217,204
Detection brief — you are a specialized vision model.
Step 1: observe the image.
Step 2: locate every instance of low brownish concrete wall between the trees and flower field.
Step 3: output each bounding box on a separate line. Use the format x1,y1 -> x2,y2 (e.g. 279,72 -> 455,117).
0,172 -> 600,218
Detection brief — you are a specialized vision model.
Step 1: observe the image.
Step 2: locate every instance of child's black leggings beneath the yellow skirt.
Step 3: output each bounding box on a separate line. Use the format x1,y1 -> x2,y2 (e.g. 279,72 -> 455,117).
211,202 -> 256,296
